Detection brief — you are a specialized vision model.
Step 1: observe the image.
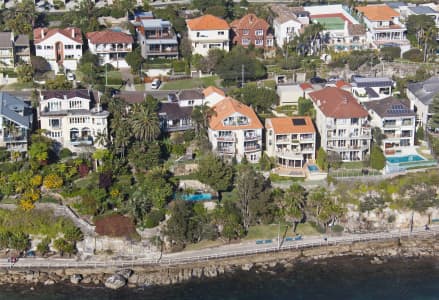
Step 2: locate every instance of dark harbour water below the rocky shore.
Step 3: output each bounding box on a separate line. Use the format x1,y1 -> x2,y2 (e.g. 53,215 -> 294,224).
0,257 -> 439,300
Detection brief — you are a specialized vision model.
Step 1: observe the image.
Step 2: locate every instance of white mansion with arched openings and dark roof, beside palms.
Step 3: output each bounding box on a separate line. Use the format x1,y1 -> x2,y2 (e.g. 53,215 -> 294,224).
38,90 -> 109,152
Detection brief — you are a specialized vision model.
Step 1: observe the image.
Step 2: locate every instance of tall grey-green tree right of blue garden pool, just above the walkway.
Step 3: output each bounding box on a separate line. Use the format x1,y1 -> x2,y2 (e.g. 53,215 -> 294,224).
235,165 -> 270,231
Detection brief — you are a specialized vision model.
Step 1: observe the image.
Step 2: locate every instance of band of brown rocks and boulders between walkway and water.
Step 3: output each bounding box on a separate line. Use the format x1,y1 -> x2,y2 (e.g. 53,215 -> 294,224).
0,236 -> 439,289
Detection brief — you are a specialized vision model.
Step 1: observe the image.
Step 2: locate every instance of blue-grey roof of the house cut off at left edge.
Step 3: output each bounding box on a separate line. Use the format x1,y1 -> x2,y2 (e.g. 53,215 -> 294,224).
0,92 -> 32,129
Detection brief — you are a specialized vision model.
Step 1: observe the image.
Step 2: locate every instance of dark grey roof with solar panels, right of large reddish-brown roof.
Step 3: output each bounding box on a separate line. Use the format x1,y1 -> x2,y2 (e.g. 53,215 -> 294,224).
363,97 -> 416,118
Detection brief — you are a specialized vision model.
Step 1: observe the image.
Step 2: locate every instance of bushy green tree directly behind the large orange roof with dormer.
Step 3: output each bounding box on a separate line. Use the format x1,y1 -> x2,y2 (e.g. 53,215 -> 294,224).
240,83 -> 279,112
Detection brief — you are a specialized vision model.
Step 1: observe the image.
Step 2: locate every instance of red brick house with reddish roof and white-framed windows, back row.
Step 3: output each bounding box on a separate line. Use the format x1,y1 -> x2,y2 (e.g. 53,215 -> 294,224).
230,14 -> 274,48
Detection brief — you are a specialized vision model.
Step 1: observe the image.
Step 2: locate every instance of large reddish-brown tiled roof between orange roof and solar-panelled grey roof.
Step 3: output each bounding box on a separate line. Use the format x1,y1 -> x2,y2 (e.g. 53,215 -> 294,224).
309,87 -> 368,119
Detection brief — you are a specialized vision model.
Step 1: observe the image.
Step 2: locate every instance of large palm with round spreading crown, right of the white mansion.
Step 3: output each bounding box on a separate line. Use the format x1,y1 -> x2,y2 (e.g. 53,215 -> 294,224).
130,103 -> 160,142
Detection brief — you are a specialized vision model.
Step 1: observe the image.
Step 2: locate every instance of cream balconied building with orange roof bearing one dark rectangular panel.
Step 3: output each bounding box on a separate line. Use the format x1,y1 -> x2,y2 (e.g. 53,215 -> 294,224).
265,116 -> 316,168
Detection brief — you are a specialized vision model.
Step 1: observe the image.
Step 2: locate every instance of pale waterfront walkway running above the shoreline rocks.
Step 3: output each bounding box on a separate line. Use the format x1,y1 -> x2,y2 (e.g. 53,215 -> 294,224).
0,225 -> 439,269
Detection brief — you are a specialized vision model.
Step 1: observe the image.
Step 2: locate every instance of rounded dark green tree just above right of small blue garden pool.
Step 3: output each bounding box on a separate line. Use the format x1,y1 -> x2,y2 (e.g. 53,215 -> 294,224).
197,153 -> 233,191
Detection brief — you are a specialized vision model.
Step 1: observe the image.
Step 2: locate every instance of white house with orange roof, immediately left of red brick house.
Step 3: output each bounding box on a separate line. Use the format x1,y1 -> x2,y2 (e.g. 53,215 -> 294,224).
186,15 -> 230,56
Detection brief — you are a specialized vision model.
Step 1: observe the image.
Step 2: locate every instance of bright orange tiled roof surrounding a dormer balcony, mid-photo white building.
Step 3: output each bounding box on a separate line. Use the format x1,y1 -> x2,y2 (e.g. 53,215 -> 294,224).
209,97 -> 264,130
